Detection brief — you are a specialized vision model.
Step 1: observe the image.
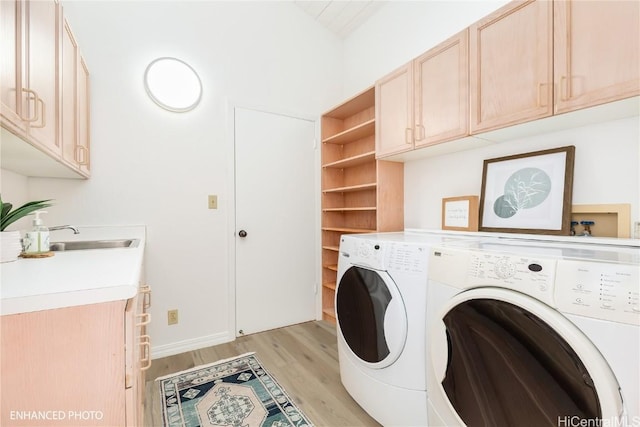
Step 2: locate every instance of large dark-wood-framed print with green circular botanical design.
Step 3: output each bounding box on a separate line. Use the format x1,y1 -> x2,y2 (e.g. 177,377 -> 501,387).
480,146 -> 575,235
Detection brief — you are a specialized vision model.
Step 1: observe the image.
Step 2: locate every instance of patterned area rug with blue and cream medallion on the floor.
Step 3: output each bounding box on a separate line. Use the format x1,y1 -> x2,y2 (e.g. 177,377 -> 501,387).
156,353 -> 313,427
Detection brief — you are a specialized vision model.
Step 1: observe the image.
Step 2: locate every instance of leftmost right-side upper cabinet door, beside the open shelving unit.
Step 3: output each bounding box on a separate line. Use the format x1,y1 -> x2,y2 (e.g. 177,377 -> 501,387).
376,62 -> 413,158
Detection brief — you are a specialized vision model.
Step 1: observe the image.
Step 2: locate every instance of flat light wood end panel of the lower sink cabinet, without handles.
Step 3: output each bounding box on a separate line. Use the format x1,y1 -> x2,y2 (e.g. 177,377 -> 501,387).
0,301 -> 125,427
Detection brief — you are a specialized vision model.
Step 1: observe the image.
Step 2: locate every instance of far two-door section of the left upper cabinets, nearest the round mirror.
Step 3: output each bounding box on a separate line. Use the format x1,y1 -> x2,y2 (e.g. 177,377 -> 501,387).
61,20 -> 90,176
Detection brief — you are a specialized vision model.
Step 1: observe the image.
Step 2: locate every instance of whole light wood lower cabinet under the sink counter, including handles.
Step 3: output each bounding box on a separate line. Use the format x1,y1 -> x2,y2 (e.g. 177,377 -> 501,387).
0,287 -> 151,426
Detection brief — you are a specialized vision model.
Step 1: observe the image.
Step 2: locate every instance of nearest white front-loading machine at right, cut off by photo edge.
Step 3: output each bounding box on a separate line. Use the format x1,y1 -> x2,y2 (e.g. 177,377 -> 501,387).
426,240 -> 640,427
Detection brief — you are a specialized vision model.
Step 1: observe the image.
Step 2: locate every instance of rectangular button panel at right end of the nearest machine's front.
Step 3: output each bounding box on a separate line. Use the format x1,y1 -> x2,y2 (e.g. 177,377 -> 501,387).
555,260 -> 640,325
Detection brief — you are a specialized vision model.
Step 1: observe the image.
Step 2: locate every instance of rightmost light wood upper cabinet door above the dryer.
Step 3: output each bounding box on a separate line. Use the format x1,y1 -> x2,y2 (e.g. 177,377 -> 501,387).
554,0 -> 640,113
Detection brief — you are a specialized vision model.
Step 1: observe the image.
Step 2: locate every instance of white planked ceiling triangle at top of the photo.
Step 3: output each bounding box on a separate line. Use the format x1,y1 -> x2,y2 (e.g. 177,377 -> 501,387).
294,0 -> 387,39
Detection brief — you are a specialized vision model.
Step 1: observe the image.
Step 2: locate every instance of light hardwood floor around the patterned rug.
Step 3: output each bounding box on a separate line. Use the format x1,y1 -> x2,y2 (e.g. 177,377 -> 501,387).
145,321 -> 380,427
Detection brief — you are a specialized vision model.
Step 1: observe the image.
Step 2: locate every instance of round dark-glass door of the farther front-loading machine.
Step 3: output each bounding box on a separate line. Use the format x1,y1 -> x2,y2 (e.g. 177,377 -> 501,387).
336,266 -> 407,368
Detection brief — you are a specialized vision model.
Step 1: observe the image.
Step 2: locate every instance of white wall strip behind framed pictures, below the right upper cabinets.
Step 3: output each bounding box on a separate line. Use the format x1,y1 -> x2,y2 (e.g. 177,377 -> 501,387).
404,117 -> 640,229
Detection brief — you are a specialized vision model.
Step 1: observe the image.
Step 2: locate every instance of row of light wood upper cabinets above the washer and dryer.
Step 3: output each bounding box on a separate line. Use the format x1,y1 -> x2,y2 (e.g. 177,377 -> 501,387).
376,0 -> 640,160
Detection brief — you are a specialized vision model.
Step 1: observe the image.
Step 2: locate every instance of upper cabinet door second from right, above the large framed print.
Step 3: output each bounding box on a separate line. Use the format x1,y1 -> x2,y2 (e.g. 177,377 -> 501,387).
469,0 -> 553,133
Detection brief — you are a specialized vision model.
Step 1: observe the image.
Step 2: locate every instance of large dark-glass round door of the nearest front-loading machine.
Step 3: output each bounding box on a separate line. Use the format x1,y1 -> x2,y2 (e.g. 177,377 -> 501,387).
432,290 -> 622,427
